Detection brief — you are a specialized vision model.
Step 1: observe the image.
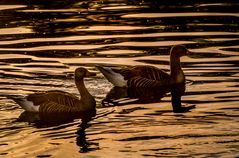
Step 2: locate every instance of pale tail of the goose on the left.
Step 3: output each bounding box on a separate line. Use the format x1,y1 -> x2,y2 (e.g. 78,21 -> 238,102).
7,96 -> 40,112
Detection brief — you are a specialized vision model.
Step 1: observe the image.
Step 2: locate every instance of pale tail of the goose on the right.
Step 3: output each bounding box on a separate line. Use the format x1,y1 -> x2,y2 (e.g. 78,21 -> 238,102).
96,65 -> 127,87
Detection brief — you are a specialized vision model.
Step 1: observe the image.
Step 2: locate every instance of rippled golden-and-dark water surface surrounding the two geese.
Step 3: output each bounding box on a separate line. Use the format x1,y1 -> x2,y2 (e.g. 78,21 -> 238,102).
0,0 -> 239,158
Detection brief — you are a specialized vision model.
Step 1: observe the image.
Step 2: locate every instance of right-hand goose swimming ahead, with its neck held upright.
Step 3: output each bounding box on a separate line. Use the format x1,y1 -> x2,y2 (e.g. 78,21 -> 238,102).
96,45 -> 191,88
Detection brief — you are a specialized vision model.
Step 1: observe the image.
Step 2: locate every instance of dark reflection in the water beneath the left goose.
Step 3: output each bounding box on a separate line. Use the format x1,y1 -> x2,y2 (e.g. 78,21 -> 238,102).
17,110 -> 100,152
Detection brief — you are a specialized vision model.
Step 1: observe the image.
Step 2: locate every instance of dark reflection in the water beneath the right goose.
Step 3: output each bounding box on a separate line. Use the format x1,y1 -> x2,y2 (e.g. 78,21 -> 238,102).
102,83 -> 195,113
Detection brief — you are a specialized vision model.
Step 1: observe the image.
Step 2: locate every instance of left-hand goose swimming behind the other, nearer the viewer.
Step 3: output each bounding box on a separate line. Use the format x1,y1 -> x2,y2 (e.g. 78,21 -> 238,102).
11,67 -> 96,113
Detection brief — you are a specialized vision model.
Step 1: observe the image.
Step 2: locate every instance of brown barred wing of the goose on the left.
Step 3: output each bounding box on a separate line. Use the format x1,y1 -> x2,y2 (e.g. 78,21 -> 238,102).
27,91 -> 79,107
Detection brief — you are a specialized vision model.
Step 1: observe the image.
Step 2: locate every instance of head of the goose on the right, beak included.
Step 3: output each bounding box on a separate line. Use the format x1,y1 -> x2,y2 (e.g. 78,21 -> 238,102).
170,45 -> 191,58
